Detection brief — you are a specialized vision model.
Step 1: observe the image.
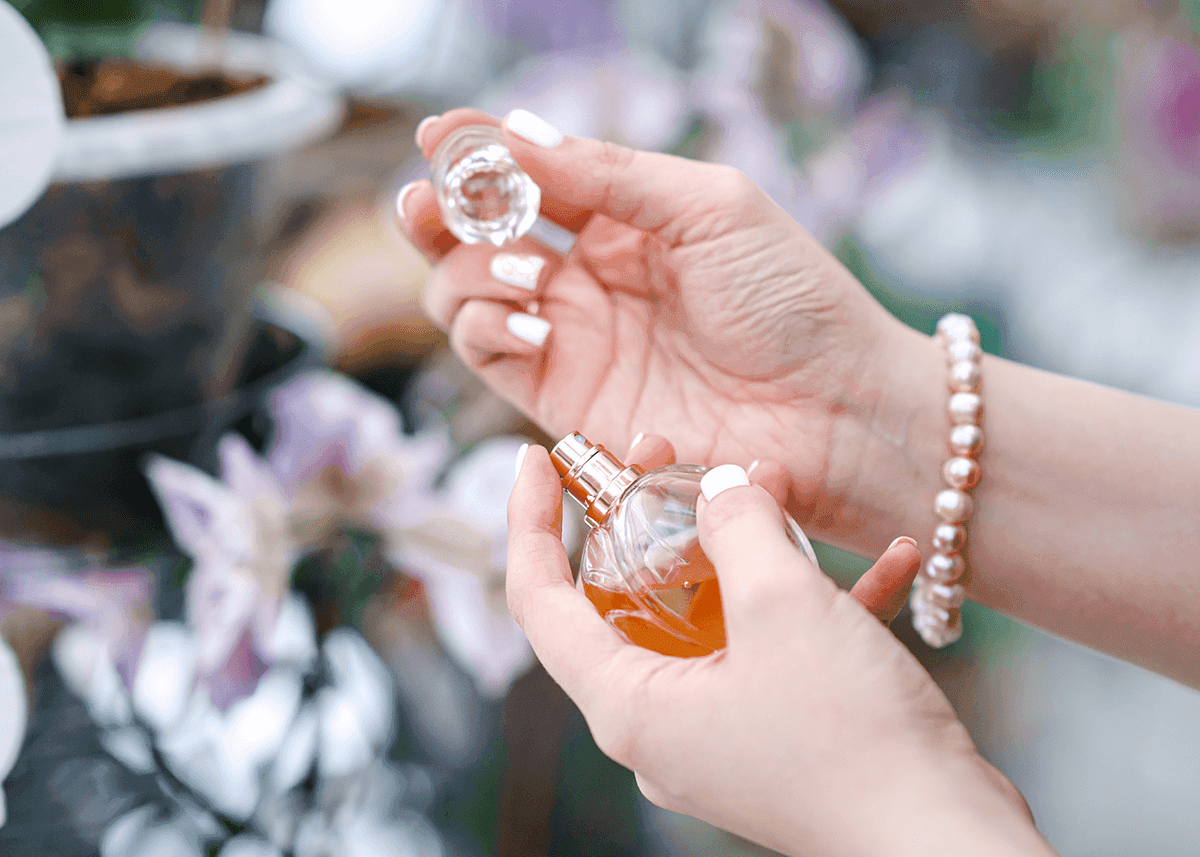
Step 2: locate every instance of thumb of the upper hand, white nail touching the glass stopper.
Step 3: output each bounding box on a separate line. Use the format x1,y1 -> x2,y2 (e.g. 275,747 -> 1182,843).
502,110 -> 767,245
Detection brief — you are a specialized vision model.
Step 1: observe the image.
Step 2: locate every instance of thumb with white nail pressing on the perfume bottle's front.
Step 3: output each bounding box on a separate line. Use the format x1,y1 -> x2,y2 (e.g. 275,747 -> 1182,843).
696,465 -> 838,641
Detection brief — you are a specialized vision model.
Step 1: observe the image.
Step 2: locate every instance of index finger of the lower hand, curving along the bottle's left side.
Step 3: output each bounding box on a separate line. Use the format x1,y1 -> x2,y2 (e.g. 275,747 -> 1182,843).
506,445 -> 662,715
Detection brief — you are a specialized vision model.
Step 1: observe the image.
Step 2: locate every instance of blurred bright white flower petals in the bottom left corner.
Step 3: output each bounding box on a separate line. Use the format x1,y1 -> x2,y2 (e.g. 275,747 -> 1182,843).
55,594 -> 417,857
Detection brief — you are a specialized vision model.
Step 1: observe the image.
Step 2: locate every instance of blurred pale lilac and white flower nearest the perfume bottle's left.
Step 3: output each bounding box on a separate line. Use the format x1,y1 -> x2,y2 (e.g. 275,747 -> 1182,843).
268,372 -> 533,695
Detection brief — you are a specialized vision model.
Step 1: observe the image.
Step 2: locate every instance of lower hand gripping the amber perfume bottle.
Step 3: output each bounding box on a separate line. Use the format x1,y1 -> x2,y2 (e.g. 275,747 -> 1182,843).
508,447 -> 1050,857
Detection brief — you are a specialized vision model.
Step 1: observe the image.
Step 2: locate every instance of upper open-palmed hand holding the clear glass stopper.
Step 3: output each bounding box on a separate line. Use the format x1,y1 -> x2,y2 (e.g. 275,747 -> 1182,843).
398,109 -> 898,532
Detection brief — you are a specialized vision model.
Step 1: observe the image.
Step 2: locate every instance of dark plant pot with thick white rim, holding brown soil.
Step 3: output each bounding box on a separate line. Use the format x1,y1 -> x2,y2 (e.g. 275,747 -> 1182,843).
0,26 -> 341,543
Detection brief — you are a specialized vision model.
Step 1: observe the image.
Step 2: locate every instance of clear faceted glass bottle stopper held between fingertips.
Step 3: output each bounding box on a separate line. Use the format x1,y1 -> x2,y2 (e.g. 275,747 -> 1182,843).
430,125 -> 541,247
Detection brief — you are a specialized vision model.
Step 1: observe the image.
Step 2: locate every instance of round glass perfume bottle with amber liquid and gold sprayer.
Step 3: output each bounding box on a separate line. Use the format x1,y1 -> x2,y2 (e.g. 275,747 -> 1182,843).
550,432 -> 817,658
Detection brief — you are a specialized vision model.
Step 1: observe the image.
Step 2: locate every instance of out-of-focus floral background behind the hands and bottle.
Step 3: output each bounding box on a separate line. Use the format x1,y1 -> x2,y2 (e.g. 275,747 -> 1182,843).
0,0 -> 1200,857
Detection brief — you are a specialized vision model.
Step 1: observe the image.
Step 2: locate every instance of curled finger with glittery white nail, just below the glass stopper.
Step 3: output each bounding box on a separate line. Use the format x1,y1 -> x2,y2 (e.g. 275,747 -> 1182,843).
421,239 -> 557,330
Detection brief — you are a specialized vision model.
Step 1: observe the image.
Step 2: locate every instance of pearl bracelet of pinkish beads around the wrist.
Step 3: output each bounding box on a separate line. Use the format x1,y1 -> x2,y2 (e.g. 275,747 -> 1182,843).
908,312 -> 983,648
